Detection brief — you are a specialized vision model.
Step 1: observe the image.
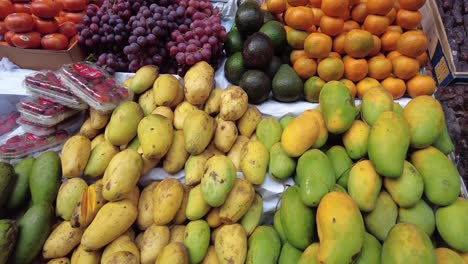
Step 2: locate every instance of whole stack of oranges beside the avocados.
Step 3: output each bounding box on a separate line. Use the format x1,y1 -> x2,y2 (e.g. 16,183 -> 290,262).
263,0 -> 435,99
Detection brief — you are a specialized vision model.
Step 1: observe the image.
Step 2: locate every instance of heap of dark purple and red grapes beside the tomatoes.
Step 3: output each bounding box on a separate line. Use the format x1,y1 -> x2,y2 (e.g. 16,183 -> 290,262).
78,0 -> 227,75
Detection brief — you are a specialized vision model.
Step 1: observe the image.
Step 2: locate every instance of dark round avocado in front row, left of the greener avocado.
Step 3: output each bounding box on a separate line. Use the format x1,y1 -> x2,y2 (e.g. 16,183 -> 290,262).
239,70 -> 271,104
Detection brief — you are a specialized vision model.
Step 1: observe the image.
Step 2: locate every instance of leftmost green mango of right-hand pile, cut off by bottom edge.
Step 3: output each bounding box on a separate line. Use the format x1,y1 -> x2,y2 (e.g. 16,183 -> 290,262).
245,225 -> 281,264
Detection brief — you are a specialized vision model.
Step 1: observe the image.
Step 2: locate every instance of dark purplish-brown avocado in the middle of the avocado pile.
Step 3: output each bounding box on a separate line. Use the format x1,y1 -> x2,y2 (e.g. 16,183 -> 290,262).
242,32 -> 273,69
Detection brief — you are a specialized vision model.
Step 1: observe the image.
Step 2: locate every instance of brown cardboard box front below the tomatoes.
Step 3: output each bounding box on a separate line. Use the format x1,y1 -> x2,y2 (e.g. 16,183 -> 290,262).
0,44 -> 86,70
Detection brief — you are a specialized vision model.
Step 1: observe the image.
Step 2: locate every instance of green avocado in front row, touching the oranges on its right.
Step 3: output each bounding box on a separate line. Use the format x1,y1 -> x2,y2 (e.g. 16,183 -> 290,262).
272,64 -> 304,102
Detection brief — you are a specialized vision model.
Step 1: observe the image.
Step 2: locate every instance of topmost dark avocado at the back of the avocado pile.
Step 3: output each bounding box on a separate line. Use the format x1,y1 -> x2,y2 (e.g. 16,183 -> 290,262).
235,0 -> 263,36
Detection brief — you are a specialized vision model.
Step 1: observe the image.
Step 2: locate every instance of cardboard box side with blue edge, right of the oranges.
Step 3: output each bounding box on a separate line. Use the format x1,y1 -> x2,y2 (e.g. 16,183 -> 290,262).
420,0 -> 468,87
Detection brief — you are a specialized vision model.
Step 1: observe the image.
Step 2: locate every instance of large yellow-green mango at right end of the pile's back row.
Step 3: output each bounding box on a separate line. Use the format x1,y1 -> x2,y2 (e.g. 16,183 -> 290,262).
403,95 -> 445,149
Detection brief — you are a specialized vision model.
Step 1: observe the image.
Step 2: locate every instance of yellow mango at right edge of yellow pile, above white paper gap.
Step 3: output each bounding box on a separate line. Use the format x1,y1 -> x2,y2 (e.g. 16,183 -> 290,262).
240,140 -> 270,185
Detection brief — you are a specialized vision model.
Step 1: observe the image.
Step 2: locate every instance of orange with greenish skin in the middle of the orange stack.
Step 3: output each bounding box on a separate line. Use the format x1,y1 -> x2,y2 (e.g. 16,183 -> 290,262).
344,29 -> 374,58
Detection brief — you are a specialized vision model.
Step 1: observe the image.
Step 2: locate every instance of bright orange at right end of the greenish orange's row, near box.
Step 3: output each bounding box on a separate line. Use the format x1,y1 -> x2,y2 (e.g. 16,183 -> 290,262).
397,30 -> 429,58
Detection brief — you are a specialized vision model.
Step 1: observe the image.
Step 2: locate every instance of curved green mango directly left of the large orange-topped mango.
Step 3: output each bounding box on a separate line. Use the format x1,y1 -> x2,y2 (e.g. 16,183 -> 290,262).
280,186 -> 315,250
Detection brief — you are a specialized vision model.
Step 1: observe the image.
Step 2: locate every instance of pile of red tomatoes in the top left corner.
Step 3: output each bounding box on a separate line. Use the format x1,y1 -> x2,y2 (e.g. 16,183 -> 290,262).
0,0 -> 98,50
